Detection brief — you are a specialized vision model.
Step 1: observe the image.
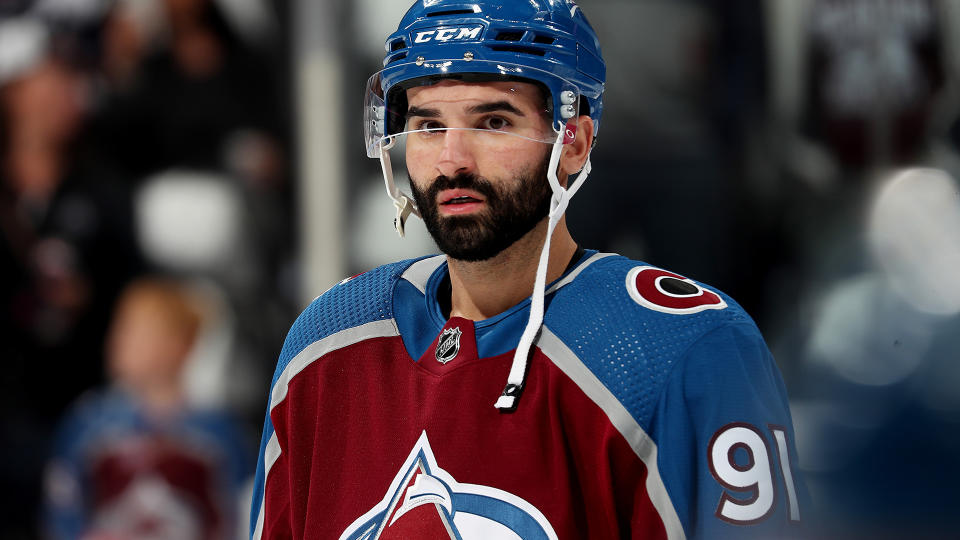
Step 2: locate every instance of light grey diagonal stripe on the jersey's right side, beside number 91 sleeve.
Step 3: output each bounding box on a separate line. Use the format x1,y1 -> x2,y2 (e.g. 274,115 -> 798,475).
537,324 -> 686,540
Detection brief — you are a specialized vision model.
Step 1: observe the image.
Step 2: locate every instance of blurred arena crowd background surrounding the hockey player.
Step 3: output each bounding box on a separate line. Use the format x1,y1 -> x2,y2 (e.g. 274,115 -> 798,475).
0,0 -> 960,539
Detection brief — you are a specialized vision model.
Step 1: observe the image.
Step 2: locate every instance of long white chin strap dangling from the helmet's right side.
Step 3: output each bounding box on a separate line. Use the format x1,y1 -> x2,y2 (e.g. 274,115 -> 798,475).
494,130 -> 590,412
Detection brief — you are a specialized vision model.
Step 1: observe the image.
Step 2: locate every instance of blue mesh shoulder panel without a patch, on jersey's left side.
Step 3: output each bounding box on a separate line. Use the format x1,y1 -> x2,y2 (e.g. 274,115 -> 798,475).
277,259 -> 432,380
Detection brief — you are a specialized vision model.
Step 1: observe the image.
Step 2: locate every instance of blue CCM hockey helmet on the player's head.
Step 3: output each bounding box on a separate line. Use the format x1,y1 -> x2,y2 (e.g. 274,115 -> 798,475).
364,0 -> 606,157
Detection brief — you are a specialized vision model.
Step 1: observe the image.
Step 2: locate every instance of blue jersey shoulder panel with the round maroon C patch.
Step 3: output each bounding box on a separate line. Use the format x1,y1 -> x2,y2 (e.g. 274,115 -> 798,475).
545,256 -> 760,429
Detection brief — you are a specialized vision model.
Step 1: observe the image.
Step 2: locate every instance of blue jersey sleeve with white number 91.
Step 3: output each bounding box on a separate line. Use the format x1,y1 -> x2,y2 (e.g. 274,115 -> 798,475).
651,323 -> 809,538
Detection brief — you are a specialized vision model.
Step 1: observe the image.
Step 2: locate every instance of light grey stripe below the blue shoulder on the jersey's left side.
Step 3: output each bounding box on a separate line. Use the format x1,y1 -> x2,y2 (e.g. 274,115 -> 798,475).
251,319 -> 400,540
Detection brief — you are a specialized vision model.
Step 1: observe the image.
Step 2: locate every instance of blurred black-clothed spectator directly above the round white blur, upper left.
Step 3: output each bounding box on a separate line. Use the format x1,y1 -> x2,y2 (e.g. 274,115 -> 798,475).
93,0 -> 285,190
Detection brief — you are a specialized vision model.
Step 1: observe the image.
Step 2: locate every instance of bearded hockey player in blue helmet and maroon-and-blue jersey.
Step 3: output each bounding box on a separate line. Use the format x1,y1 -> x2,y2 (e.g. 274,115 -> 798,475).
251,0 -> 805,540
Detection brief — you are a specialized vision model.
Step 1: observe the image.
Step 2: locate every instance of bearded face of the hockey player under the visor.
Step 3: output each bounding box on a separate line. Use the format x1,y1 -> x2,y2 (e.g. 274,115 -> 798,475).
407,82 -> 552,261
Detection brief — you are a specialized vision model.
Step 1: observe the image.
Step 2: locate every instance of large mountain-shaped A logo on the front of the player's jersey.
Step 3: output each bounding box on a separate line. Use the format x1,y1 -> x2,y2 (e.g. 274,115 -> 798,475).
340,431 -> 557,540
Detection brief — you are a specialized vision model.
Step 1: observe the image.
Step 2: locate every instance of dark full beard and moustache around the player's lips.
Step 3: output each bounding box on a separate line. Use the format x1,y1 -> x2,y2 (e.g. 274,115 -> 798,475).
410,153 -> 553,262
